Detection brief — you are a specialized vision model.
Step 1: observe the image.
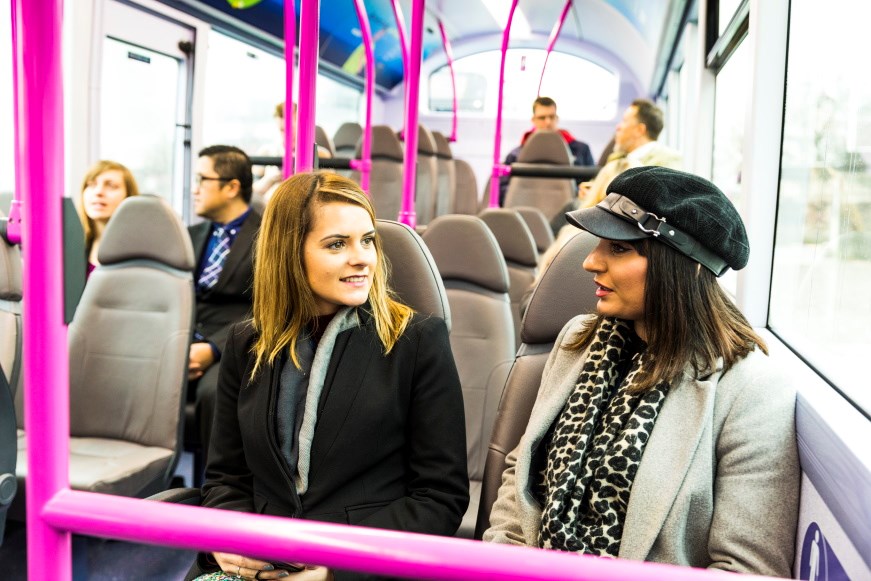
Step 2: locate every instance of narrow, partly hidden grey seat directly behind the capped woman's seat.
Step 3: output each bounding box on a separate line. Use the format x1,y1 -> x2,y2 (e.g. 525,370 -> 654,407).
478,208 -> 538,345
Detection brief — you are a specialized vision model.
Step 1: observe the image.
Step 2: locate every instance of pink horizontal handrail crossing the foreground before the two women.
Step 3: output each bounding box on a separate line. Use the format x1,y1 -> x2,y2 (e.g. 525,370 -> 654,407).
43,490 -> 768,581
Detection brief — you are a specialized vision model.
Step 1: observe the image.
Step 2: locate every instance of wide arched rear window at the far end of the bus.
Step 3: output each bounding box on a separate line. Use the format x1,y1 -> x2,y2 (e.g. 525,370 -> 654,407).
428,49 -> 620,121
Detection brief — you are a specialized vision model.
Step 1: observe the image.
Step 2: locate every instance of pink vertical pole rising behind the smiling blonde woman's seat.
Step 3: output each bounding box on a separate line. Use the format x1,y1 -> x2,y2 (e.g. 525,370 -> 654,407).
399,0 -> 424,228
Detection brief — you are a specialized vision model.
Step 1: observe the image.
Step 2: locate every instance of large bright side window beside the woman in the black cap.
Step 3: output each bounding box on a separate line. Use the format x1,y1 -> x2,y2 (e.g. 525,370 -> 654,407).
769,0 -> 871,411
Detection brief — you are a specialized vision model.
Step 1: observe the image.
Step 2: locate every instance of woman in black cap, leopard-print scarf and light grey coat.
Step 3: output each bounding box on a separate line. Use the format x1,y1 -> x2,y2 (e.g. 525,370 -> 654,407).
484,167 -> 800,577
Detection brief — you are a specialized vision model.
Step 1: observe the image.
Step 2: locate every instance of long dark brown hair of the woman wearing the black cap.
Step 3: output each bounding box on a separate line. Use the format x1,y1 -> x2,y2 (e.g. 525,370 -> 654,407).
564,239 -> 768,391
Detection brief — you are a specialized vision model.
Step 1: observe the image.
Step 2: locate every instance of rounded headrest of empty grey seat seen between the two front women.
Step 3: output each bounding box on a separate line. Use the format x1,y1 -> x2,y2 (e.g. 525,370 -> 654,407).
423,214 -> 509,293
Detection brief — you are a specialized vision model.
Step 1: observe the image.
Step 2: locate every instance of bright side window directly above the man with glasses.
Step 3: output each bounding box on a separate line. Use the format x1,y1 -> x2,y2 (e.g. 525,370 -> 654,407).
203,30 -> 286,155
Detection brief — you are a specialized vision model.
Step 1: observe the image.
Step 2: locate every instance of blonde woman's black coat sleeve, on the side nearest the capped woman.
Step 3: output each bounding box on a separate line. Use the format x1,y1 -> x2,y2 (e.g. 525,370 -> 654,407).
359,317 -> 469,535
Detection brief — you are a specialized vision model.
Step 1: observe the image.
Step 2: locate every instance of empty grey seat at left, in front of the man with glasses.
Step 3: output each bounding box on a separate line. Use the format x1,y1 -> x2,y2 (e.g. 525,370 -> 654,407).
16,195 -> 195,514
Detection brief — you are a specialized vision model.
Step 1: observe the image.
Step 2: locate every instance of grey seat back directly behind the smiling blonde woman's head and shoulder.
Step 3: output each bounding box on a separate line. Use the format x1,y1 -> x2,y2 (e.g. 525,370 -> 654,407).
375,220 -> 451,330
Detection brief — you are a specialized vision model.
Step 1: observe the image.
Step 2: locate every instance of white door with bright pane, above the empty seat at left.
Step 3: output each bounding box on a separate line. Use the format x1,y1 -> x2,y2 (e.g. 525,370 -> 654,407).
92,0 -> 195,220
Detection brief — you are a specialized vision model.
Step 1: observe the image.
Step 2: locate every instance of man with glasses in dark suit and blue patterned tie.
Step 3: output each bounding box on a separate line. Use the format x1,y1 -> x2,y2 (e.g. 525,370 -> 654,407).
188,145 -> 260,462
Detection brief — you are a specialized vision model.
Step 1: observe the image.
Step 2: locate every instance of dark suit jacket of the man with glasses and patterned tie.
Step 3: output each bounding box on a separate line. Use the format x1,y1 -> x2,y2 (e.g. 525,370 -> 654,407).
188,210 -> 261,349
